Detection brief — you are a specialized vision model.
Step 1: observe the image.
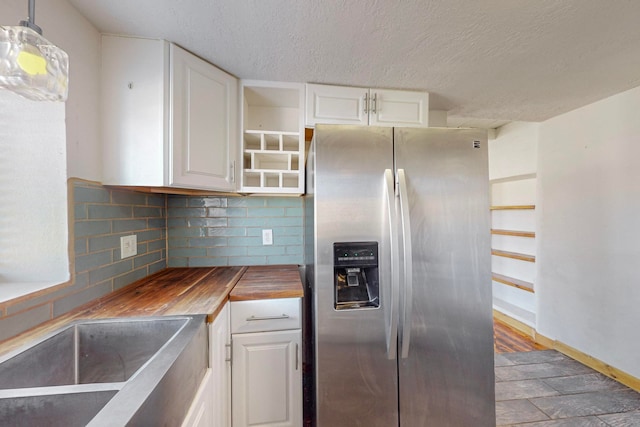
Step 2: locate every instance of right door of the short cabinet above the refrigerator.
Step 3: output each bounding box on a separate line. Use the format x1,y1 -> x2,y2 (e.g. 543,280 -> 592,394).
369,89 -> 429,127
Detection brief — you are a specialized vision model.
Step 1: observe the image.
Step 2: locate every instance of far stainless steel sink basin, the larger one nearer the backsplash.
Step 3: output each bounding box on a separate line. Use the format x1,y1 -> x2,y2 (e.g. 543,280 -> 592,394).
0,318 -> 188,390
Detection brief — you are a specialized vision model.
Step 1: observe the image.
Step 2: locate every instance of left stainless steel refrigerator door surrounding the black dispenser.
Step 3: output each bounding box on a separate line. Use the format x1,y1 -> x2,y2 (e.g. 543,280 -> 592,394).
313,125 -> 398,427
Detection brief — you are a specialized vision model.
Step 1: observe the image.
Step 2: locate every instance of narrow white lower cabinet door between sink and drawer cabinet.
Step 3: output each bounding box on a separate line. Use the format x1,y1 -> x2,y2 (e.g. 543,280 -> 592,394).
209,303 -> 231,427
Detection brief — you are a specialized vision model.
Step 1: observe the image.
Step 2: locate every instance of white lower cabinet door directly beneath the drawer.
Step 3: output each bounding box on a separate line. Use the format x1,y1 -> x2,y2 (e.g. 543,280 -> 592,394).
232,329 -> 302,427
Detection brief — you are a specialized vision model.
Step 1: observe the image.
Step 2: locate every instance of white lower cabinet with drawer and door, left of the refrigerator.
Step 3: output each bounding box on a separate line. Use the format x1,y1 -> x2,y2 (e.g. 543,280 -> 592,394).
231,298 -> 302,427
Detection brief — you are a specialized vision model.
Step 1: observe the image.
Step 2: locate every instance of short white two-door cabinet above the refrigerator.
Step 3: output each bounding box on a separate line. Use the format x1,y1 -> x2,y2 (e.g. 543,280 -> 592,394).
305,84 -> 429,127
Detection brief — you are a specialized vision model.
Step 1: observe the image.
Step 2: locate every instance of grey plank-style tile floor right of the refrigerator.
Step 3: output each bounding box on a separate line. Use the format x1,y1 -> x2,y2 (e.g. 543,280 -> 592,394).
495,350 -> 640,427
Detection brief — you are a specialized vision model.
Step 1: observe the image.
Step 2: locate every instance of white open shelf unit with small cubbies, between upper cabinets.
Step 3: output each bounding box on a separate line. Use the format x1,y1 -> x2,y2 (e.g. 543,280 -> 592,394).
241,81 -> 305,194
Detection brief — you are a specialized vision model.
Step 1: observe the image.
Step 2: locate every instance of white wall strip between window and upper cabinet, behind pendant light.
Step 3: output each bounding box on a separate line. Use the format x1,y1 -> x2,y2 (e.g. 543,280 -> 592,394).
0,0 -> 102,181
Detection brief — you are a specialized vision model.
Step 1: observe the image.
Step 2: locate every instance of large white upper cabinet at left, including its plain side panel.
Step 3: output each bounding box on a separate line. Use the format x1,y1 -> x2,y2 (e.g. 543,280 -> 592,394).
102,35 -> 238,191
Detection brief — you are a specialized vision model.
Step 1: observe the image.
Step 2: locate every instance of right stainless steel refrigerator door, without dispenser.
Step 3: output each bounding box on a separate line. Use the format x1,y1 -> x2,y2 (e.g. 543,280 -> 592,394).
394,128 -> 495,427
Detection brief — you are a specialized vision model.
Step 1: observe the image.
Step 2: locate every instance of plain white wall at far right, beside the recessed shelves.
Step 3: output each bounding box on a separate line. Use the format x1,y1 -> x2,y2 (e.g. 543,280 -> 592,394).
536,87 -> 640,377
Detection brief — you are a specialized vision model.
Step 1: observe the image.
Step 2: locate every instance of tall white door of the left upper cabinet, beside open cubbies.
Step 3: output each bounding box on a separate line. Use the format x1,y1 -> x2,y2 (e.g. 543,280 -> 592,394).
168,45 -> 238,191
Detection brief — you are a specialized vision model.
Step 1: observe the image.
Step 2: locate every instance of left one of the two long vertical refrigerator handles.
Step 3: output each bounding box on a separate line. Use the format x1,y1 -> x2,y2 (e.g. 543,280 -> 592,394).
384,169 -> 400,360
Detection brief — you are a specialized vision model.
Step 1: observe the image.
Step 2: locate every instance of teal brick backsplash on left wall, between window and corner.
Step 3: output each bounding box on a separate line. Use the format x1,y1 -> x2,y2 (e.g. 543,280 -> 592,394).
0,179 -> 168,341
